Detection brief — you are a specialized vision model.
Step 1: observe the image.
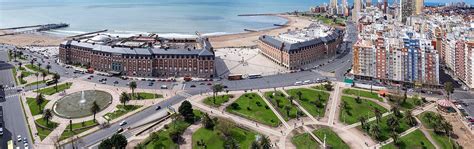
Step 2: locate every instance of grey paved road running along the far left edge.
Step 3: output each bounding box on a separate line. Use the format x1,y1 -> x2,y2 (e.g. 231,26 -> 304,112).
0,47 -> 31,148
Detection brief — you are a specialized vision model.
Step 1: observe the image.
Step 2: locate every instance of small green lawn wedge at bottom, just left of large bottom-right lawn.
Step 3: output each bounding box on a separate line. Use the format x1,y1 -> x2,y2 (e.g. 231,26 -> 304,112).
313,128 -> 350,149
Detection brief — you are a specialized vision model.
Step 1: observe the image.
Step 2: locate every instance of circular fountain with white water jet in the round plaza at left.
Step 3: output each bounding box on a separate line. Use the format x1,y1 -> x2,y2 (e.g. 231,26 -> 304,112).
53,90 -> 112,118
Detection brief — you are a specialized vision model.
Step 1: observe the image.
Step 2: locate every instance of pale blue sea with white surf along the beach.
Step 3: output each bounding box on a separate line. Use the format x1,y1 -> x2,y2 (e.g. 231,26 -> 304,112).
0,0 -> 320,35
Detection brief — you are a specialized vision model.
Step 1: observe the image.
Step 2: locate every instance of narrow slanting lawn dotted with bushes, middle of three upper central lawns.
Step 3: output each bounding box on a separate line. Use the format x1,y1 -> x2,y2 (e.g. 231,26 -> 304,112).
264,91 -> 302,121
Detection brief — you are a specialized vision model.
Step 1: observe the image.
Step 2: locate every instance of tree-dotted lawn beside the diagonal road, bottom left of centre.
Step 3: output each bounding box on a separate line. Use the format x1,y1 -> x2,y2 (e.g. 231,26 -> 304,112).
142,120 -> 190,149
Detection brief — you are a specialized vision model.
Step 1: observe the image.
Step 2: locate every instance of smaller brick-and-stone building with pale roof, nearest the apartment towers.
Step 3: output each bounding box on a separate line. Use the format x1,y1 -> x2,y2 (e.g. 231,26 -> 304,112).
258,24 -> 344,70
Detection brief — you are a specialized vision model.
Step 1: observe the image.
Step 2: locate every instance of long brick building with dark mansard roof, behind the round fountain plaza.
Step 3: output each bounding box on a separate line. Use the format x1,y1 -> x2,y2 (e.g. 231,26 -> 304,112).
59,35 -> 215,78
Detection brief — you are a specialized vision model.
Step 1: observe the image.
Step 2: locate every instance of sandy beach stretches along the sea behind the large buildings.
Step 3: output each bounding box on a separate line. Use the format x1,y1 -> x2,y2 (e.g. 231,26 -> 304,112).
0,14 -> 311,48
